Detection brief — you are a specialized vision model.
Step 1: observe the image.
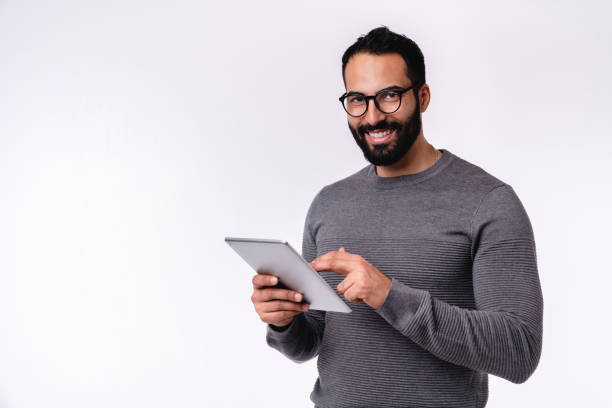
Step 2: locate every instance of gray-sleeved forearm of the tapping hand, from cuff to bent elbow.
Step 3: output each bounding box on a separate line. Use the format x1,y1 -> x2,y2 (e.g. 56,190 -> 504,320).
376,279 -> 542,383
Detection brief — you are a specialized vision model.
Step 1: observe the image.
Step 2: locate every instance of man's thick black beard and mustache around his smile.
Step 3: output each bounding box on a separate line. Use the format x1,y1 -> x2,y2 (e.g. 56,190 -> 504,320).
349,98 -> 421,166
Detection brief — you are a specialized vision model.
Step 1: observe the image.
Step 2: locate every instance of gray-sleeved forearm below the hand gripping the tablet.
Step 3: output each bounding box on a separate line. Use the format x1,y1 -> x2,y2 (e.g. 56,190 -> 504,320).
266,310 -> 324,363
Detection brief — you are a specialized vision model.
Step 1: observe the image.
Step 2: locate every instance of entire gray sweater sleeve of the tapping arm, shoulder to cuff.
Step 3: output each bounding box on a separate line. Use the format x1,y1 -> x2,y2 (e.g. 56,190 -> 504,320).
376,184 -> 543,384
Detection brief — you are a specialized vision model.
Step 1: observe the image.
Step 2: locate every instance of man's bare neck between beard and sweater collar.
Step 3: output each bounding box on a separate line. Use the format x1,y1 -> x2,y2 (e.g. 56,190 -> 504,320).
376,132 -> 442,177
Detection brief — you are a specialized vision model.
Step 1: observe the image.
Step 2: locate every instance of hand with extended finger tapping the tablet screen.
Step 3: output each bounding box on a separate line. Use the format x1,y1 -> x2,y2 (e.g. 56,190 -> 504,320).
310,247 -> 391,309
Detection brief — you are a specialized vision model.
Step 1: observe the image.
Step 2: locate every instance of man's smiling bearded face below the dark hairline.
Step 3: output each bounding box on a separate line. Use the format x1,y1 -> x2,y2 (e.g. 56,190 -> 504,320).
344,53 -> 421,166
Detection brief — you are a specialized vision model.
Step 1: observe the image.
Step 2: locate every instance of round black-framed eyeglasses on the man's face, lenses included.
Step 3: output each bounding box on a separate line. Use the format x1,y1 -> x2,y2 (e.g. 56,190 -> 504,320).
338,85 -> 414,117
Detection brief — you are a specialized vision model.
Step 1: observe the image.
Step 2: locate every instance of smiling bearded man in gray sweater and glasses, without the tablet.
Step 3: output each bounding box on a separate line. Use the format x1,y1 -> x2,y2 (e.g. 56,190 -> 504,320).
252,26 -> 543,408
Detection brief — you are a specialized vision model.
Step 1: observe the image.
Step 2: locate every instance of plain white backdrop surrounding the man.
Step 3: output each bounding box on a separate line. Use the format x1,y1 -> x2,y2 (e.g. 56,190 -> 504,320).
0,0 -> 612,408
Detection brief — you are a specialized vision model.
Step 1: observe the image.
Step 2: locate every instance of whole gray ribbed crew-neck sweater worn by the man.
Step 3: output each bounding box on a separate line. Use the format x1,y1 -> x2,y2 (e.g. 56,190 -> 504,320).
266,149 -> 543,408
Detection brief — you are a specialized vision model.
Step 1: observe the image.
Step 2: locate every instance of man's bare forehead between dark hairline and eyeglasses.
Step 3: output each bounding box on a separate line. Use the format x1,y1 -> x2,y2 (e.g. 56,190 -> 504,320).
344,53 -> 411,93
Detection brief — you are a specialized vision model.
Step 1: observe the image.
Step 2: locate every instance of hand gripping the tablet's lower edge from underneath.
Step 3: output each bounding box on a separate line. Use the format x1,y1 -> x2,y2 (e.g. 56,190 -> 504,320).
251,273 -> 310,327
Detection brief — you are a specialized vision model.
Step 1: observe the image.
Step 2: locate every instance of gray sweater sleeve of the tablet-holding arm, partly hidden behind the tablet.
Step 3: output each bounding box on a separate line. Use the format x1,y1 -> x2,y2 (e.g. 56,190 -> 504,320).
266,190 -> 325,363
